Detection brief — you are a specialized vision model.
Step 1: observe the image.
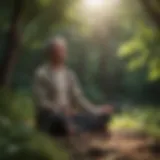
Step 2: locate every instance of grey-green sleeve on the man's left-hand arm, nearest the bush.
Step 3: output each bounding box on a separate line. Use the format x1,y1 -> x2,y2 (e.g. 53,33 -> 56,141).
33,71 -> 53,108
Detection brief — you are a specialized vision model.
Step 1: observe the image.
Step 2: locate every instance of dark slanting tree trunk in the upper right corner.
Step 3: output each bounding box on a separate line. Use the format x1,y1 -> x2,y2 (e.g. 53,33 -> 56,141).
140,0 -> 160,30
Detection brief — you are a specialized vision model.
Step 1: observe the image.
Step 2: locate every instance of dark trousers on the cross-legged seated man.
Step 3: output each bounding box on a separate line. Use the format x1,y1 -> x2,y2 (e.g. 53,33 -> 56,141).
37,109 -> 111,137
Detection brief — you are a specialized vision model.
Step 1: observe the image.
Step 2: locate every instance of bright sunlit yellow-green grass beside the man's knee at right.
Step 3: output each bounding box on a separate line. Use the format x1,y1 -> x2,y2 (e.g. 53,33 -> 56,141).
110,106 -> 160,136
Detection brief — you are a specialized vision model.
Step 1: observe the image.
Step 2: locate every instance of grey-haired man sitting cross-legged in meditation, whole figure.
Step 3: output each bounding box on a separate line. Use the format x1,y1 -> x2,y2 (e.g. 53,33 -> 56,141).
33,37 -> 112,139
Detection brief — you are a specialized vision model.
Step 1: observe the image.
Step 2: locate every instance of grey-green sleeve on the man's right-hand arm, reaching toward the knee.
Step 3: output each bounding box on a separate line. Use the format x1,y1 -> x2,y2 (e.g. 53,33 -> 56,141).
71,73 -> 99,114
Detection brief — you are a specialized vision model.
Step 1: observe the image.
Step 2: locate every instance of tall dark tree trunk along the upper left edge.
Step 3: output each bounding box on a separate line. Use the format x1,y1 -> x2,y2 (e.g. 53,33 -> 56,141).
0,0 -> 23,87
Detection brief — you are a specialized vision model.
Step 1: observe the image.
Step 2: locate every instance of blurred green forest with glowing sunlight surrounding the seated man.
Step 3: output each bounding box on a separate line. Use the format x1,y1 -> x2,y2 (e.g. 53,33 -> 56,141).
0,0 -> 160,160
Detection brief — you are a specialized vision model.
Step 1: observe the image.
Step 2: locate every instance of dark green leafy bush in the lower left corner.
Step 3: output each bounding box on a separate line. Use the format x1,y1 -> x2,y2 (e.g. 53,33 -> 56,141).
0,90 -> 69,160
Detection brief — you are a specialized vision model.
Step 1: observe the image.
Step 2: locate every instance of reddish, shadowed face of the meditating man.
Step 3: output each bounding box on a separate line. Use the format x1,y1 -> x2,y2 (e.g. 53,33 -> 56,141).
50,43 -> 67,63
